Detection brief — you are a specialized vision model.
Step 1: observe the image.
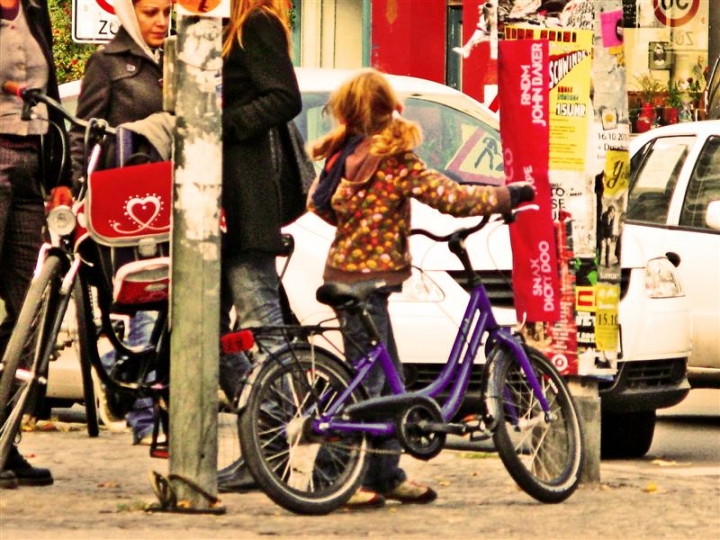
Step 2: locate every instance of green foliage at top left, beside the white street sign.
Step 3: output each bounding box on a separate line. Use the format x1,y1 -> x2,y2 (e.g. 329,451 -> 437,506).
48,0 -> 97,84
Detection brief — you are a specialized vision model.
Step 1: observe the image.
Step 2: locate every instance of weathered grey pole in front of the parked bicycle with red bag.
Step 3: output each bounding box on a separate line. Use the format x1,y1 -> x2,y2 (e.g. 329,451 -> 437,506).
169,11 -> 222,512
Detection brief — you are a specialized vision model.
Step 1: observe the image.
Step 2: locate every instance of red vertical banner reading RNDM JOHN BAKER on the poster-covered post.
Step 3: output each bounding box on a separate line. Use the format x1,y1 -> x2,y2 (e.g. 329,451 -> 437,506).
498,39 -> 560,322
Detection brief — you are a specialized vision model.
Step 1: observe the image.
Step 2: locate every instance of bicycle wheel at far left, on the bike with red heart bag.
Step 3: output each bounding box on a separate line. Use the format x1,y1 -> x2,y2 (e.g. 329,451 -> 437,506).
0,255 -> 63,468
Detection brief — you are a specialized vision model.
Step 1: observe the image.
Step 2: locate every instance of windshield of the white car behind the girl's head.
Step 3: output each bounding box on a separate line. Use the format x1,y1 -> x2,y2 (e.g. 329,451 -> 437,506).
295,92 -> 504,184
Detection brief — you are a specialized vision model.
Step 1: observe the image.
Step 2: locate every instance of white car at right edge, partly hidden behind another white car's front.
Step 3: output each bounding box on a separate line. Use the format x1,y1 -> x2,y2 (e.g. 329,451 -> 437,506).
623,120 -> 720,388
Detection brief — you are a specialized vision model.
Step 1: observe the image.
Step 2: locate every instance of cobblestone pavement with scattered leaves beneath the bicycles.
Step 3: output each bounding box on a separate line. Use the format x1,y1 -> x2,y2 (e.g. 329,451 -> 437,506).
0,416 -> 720,540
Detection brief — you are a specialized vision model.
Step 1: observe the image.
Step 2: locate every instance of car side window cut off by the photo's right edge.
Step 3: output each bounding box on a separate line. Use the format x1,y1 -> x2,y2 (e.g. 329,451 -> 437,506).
679,137 -> 720,230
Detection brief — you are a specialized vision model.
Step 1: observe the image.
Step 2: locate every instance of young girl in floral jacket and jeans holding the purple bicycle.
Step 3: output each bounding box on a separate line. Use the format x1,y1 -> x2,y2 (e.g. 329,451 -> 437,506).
308,69 -> 535,507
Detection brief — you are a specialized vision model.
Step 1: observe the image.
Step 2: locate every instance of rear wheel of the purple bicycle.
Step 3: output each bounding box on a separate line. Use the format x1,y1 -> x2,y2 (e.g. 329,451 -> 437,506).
239,344 -> 368,515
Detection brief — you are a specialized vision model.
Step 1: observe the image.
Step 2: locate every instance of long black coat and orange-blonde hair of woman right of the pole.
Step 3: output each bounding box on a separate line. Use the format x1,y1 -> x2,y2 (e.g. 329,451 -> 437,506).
223,0 -> 302,258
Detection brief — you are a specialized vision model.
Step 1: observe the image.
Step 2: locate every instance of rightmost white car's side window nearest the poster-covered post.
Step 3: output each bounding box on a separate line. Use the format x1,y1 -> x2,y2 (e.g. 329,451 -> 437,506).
626,136 -> 694,224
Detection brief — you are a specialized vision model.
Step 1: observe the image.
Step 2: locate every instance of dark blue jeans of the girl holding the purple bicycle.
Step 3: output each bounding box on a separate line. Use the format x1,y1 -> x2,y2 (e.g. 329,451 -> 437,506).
342,288 -> 407,493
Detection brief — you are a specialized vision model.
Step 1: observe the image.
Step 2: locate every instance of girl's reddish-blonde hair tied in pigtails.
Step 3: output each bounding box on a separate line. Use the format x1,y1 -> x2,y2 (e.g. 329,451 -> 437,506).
310,68 -> 422,159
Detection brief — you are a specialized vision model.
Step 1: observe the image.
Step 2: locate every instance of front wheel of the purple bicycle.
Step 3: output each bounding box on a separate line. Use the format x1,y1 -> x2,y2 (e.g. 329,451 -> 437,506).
488,348 -> 583,503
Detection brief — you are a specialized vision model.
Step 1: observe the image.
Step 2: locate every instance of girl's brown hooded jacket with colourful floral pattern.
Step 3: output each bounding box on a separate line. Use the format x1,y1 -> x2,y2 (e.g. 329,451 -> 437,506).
308,140 -> 510,285
